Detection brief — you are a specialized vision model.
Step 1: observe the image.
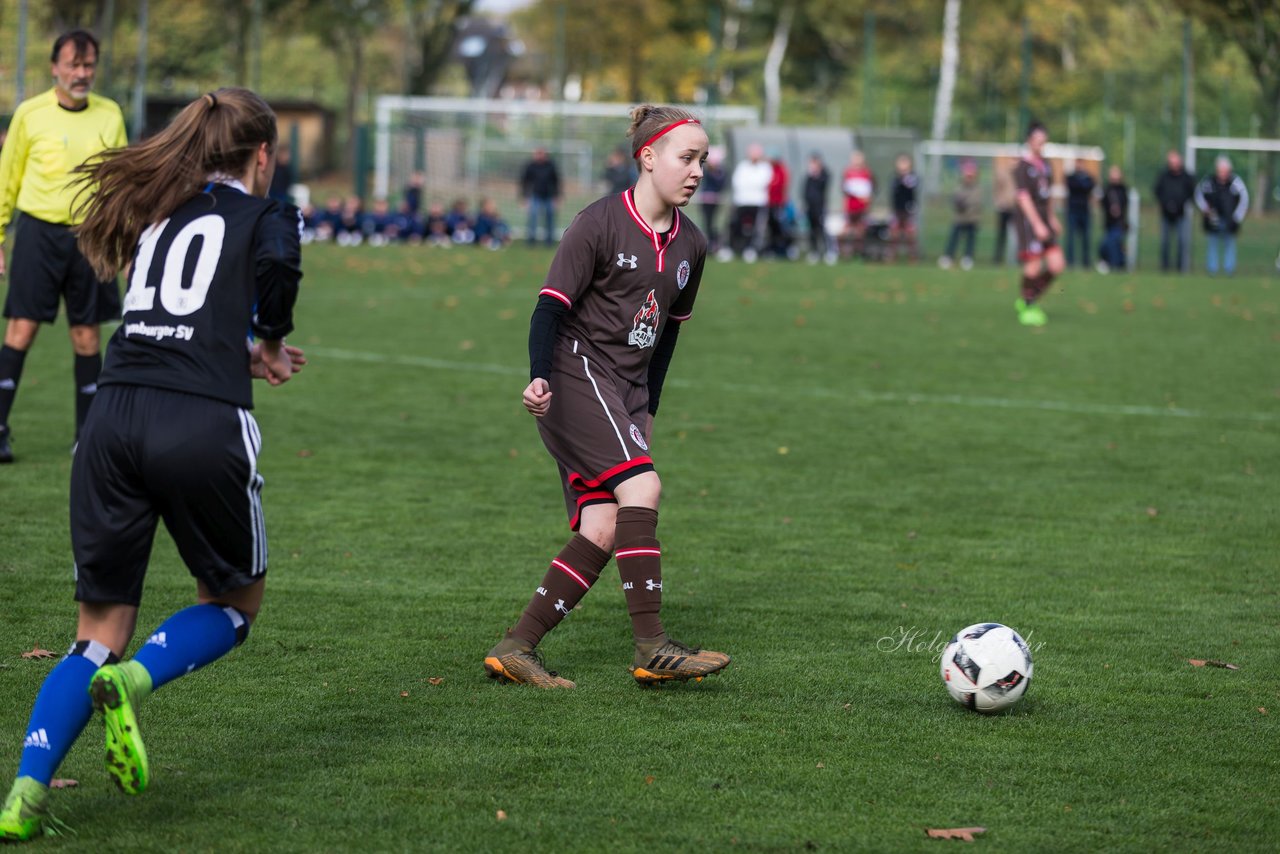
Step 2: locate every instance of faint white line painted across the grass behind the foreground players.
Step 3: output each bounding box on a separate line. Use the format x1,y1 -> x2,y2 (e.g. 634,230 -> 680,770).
307,347 -> 1280,424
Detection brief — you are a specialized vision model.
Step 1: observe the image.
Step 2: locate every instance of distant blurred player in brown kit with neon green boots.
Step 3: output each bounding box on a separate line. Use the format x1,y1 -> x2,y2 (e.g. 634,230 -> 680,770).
1014,122 -> 1066,326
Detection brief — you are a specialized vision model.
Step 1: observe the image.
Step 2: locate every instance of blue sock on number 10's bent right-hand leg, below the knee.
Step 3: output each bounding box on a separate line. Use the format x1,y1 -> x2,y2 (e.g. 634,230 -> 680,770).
133,604 -> 248,690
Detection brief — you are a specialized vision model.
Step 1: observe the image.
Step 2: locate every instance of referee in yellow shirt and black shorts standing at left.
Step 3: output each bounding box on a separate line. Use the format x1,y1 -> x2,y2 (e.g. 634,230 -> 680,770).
0,29 -> 128,462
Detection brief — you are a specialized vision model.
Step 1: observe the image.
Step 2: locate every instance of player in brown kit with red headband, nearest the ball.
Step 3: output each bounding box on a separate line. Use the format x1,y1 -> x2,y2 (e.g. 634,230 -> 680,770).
484,105 -> 730,688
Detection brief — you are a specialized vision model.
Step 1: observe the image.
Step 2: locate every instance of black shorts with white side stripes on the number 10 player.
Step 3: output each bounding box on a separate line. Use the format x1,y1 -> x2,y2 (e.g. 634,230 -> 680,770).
70,385 -> 266,606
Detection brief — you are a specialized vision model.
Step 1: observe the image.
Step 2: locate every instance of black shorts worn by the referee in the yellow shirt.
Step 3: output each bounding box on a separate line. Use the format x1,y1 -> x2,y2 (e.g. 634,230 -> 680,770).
4,213 -> 120,326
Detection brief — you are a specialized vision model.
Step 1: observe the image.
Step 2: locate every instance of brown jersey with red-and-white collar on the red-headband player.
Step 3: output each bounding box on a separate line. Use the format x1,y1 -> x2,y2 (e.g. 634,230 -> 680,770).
540,188 -> 707,385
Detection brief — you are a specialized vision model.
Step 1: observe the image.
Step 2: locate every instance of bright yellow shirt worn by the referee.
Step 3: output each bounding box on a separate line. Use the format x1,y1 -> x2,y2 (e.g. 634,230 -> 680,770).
0,90 -> 128,242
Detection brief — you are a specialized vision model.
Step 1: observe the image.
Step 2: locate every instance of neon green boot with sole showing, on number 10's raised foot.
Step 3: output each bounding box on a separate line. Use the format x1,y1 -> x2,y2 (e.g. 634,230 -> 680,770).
88,662 -> 151,795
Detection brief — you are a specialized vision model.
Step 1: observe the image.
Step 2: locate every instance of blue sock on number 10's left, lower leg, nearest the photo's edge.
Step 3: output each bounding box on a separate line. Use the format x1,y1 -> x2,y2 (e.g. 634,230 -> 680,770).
18,640 -> 118,786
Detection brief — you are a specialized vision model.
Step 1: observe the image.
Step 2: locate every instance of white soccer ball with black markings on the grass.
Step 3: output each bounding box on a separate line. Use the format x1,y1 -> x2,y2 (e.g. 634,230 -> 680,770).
942,622 -> 1032,712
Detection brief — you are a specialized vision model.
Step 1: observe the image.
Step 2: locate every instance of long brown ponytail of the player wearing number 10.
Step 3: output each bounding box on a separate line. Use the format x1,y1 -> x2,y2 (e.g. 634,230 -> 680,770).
76,88 -> 276,279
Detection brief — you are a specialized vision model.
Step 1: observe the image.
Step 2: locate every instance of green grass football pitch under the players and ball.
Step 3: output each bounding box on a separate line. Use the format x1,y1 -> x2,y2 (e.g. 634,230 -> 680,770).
0,236 -> 1280,851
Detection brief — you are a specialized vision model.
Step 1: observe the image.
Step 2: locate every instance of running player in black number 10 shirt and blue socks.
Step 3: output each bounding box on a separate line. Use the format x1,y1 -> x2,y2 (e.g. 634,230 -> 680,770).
0,88 -> 305,848
